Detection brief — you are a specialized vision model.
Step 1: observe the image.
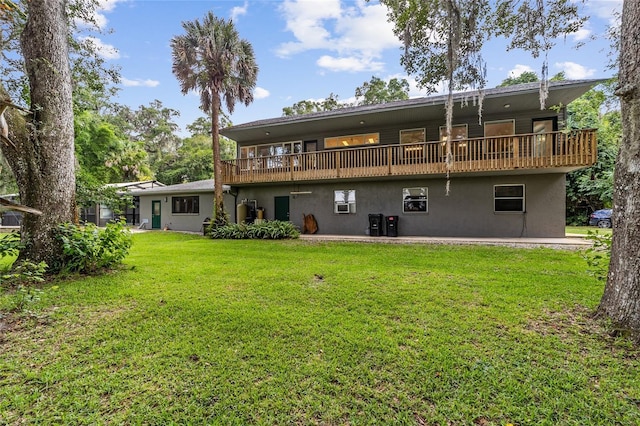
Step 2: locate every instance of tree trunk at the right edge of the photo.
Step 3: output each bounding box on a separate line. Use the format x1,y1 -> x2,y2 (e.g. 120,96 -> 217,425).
598,0 -> 640,340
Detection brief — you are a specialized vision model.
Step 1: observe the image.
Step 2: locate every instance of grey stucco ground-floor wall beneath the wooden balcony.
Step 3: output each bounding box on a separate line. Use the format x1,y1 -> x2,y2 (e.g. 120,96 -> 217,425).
232,173 -> 565,237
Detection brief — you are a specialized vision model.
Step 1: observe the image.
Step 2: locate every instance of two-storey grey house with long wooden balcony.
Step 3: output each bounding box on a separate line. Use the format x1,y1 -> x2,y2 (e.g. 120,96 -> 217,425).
219,80 -> 600,237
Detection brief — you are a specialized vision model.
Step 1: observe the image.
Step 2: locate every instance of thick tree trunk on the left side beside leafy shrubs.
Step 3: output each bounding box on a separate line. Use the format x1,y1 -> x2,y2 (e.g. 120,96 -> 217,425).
2,0 -> 75,265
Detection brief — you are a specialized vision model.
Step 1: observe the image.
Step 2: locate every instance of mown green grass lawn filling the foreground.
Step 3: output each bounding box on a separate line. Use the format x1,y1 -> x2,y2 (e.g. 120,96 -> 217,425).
0,232 -> 640,425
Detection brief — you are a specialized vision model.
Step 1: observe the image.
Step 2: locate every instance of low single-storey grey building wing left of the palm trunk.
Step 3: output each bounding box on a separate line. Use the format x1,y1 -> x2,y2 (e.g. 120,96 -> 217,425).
131,179 -> 236,232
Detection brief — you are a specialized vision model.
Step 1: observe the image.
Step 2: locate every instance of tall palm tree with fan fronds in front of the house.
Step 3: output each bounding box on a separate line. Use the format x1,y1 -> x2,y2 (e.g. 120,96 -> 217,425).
171,12 -> 258,225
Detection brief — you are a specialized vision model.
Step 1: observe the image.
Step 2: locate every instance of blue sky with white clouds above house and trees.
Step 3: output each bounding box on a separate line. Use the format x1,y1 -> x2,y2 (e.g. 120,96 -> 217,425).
85,0 -> 622,135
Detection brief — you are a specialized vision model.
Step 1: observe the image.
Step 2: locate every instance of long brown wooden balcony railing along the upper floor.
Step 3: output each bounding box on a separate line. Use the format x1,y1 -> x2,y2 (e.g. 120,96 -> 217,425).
222,129 -> 597,185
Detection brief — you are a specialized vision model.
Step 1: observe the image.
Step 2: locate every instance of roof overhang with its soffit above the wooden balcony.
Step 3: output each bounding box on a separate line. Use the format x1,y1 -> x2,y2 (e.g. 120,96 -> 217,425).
220,80 -> 603,143
